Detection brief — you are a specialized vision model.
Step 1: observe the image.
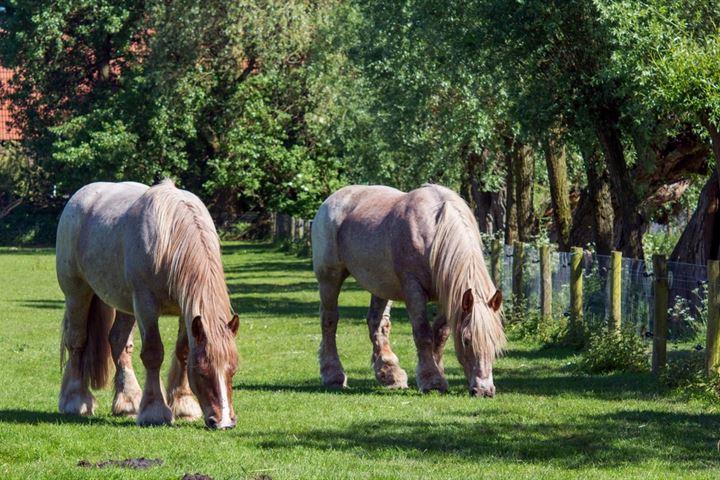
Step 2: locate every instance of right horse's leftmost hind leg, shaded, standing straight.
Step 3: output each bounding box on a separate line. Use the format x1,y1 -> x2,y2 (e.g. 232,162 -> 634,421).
317,270 -> 348,387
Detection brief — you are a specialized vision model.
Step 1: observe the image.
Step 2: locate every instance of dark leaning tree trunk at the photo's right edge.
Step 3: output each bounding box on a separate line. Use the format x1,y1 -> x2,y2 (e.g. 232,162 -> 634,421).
670,172 -> 720,265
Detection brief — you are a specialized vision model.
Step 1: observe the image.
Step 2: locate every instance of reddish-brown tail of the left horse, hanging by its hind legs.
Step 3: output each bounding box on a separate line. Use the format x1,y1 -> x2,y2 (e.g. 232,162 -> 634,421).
60,295 -> 115,389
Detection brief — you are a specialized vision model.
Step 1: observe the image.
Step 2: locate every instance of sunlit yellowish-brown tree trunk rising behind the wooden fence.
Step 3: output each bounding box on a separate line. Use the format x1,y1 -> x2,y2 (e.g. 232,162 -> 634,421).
543,136 -> 572,252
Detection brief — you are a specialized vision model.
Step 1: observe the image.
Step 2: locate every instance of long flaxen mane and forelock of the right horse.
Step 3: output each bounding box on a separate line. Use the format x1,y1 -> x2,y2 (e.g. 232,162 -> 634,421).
429,185 -> 506,358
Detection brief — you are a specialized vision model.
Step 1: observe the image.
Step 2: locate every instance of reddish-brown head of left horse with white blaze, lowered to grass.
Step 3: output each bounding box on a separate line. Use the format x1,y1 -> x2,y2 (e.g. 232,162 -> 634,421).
188,315 -> 240,428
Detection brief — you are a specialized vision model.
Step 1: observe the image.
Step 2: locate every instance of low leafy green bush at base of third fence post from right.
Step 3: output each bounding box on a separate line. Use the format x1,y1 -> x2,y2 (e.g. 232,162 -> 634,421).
580,325 -> 648,373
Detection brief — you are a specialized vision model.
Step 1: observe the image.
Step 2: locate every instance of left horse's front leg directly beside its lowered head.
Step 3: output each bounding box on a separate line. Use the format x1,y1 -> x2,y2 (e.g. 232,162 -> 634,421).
168,318 -> 202,420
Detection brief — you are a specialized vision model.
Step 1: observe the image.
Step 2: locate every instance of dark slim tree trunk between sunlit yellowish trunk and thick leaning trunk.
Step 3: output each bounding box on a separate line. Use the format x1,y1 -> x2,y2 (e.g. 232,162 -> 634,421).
580,142 -> 615,255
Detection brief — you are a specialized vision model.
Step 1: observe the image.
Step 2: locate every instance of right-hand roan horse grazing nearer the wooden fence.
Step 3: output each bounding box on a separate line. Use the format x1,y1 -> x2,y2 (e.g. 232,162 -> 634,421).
312,185 -> 505,397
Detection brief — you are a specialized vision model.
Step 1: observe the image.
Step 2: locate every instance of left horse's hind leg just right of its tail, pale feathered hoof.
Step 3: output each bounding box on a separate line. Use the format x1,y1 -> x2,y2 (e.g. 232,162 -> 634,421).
110,312 -> 142,416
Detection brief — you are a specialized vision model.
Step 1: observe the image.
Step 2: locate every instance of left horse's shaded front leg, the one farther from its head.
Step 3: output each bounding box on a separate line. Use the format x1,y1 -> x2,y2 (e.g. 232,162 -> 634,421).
133,295 -> 172,426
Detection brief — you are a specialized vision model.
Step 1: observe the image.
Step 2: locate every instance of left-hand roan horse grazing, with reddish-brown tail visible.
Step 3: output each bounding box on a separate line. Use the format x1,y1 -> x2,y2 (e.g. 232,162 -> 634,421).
57,180 -> 239,428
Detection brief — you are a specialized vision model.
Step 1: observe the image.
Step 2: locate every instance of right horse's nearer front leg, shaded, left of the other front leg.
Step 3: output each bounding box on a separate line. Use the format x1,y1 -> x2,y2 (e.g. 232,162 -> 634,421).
405,282 -> 448,393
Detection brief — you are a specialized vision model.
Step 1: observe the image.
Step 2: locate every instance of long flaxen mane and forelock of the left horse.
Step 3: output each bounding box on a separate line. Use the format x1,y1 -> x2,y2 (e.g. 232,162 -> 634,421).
144,180 -> 236,366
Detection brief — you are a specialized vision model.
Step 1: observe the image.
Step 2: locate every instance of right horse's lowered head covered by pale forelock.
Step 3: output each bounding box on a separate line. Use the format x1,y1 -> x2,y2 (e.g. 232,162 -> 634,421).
454,289 -> 505,397
